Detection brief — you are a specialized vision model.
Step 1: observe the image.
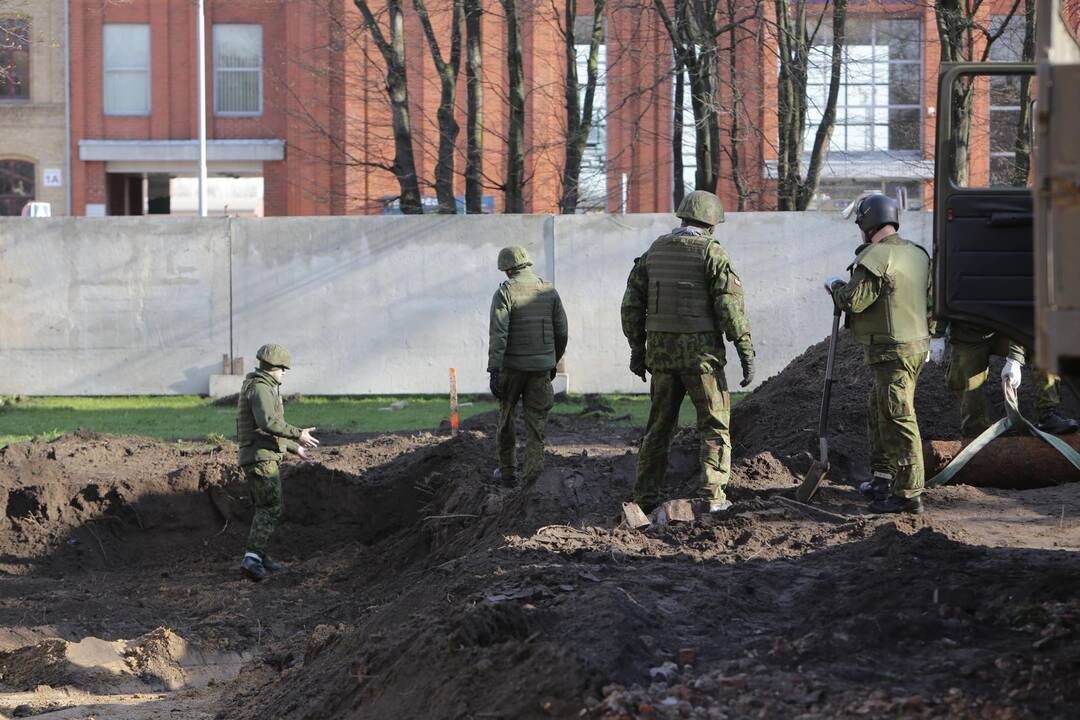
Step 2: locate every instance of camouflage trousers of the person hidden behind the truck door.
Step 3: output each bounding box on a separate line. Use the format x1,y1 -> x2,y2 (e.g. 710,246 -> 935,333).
946,341 -> 1062,437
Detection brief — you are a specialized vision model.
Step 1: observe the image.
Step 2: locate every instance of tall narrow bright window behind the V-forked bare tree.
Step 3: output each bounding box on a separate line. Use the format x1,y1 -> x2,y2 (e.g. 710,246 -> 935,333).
573,15 -> 607,213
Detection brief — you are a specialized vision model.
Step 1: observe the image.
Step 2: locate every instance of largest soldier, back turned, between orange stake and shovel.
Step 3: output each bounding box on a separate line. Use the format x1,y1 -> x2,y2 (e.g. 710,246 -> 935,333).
622,190 -> 754,512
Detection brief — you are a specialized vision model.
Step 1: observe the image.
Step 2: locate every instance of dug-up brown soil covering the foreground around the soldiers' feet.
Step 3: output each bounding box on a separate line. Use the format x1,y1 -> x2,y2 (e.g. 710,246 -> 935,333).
0,343 -> 1080,720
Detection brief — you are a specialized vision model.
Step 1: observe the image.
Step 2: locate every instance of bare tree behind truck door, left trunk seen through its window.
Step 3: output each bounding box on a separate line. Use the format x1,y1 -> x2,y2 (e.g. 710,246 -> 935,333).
934,0 -> 1019,186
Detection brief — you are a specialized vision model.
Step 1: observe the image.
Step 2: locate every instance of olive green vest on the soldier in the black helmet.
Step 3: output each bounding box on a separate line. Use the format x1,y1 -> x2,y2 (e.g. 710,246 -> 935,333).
850,235 -> 930,345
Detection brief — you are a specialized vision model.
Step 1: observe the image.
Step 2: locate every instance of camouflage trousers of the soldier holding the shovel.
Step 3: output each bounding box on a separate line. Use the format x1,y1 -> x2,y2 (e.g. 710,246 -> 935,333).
866,353 -> 926,498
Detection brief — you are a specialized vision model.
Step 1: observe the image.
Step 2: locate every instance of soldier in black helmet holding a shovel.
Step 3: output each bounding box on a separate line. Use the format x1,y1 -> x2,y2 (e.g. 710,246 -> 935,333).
825,194 -> 931,514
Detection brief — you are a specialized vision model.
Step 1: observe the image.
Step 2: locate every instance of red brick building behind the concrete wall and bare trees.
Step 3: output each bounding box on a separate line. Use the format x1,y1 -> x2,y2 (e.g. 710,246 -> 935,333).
63,0 -> 1020,215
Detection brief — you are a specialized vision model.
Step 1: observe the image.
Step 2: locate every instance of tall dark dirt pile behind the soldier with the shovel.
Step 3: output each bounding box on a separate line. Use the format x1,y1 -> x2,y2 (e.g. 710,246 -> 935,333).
731,330 -> 1080,480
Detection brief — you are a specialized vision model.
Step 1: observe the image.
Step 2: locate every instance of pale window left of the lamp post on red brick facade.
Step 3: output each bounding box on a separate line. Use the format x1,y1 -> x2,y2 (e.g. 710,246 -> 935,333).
103,24 -> 150,116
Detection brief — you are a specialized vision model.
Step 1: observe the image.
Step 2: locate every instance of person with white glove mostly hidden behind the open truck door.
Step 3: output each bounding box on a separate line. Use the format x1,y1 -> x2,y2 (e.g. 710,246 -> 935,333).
946,322 -> 1078,437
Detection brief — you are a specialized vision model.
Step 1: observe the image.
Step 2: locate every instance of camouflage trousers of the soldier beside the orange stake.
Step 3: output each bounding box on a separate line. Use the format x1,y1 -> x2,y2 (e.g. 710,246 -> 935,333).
495,368 -> 555,483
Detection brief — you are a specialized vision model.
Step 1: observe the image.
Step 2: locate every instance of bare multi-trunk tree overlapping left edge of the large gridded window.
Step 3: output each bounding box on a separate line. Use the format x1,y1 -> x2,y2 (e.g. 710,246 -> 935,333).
775,0 -> 848,210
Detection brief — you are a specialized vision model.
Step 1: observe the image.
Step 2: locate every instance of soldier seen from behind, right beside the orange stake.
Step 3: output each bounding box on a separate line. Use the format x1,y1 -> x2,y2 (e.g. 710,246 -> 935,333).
487,245 -> 567,487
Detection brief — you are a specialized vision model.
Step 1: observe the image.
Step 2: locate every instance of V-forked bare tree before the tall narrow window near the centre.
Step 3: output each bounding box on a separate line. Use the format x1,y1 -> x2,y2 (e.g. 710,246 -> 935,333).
558,0 -> 607,215
